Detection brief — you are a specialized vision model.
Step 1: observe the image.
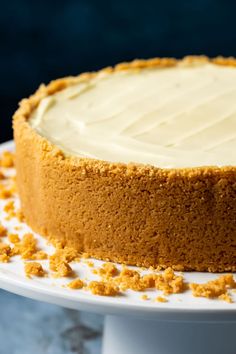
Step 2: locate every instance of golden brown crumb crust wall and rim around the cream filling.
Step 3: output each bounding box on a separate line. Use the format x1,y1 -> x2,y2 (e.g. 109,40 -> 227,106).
14,57 -> 236,271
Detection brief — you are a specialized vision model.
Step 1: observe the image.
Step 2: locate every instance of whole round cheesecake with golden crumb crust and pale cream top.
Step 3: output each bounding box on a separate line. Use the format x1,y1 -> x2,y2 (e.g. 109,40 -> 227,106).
13,57 -> 236,272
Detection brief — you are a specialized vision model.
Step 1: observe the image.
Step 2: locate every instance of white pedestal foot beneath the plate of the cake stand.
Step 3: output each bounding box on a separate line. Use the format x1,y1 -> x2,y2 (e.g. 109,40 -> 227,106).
102,316 -> 236,354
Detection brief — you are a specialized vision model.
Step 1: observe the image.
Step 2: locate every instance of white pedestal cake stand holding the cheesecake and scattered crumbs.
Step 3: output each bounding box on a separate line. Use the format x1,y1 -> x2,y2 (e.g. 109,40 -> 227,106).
0,143 -> 236,354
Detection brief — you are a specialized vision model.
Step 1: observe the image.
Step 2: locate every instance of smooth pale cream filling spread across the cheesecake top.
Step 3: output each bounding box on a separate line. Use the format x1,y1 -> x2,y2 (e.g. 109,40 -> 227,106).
30,63 -> 236,168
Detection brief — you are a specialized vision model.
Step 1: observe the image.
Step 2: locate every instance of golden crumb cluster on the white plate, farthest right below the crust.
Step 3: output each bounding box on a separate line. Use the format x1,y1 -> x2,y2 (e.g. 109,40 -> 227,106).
189,274 -> 236,302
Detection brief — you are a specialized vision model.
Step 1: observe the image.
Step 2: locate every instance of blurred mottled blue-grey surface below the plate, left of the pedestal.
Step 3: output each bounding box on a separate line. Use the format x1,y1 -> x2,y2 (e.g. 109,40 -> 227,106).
0,290 -> 103,354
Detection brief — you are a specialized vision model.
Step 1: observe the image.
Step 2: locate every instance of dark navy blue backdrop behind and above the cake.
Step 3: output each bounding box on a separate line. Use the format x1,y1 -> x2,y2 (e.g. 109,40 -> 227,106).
0,0 -> 236,141
